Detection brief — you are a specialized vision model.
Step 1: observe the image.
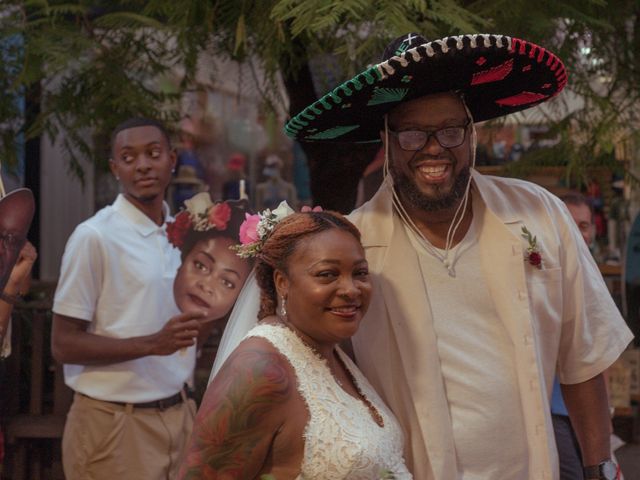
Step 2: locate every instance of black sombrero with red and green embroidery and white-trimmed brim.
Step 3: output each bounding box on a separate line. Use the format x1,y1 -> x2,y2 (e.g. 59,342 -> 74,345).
285,33 -> 567,142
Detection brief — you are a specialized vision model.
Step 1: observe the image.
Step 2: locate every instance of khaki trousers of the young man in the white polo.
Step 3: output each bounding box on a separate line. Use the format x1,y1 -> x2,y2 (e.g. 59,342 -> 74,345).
62,393 -> 196,480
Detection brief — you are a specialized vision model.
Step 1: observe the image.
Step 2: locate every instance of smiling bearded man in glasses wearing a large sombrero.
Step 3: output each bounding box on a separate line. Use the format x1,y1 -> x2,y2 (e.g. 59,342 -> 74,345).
286,34 -> 632,480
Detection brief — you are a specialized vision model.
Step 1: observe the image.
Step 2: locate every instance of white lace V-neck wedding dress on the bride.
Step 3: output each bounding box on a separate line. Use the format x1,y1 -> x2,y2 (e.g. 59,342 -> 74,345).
247,324 -> 412,480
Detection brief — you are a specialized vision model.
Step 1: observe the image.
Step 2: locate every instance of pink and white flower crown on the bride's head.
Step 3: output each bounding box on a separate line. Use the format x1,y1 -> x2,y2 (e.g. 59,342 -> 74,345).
231,200 -> 322,258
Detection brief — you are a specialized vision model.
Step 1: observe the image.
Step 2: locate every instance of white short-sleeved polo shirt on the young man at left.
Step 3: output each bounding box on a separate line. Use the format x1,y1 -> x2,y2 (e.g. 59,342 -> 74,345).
53,195 -> 195,402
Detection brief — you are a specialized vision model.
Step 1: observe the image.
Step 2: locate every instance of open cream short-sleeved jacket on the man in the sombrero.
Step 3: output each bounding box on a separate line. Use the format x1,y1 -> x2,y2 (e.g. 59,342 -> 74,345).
350,171 -> 632,480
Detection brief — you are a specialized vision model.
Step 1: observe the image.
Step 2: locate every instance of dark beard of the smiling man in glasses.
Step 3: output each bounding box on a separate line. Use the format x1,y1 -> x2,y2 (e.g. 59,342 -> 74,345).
390,161 -> 471,212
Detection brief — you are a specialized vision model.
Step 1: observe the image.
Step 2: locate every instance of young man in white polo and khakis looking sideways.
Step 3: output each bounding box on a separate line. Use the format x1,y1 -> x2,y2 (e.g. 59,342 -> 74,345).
52,118 -> 208,480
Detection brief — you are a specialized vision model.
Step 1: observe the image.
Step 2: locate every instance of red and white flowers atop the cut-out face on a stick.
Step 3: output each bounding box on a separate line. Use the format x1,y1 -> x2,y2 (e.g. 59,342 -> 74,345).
167,192 -> 231,248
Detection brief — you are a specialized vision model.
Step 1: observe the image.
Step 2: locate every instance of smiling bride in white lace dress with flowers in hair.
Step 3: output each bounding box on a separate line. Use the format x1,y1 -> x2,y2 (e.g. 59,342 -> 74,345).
179,211 -> 411,480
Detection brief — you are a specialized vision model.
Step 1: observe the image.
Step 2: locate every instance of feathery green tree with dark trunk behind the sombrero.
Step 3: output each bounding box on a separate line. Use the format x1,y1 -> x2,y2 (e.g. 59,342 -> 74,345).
0,0 -> 640,211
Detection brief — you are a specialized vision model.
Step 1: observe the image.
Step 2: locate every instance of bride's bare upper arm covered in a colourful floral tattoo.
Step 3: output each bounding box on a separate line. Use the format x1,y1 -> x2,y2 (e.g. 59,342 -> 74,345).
179,349 -> 295,480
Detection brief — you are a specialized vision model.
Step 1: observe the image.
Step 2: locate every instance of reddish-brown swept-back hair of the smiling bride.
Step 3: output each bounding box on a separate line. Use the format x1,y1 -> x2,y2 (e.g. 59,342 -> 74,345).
255,211 -> 360,320
